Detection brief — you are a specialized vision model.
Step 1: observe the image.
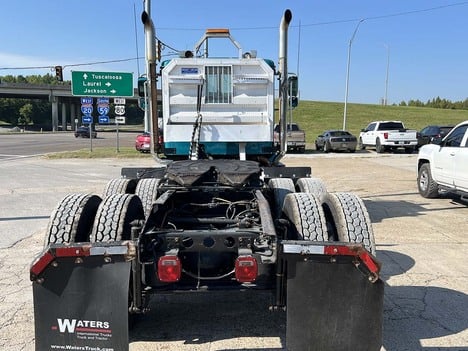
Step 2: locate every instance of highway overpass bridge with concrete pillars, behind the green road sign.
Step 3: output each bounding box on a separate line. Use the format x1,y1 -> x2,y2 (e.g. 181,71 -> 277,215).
0,82 -> 143,131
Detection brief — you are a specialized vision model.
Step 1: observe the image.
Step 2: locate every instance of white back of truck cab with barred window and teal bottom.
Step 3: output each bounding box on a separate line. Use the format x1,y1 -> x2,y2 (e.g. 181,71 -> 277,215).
162,48 -> 275,159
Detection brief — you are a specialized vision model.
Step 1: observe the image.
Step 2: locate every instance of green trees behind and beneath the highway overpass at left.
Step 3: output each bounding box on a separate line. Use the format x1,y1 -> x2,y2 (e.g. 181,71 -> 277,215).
0,74 -> 144,130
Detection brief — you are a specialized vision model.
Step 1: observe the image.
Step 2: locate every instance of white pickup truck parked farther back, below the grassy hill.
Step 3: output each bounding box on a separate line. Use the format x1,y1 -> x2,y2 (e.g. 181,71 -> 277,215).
359,121 -> 418,154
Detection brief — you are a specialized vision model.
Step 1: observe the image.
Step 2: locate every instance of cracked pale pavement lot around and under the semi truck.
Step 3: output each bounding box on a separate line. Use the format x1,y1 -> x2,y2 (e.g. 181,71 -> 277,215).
0,152 -> 468,351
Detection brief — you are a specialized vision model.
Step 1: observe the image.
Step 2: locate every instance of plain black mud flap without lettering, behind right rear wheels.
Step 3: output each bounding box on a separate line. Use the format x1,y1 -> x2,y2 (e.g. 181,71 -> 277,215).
283,243 -> 384,351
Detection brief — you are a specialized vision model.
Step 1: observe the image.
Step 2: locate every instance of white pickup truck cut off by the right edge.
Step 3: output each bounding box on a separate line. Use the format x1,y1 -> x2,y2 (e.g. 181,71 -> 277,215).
418,121 -> 468,201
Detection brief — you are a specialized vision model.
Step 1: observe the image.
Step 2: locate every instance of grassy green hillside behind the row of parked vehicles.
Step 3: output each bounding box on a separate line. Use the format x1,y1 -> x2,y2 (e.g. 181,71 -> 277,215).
288,101 -> 468,143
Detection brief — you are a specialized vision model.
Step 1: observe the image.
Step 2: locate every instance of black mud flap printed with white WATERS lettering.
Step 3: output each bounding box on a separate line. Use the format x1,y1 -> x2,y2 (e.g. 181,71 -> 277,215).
31,246 -> 131,351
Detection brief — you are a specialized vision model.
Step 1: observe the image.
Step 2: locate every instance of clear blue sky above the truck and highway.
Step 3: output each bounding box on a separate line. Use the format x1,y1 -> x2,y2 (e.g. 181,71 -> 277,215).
0,0 -> 468,104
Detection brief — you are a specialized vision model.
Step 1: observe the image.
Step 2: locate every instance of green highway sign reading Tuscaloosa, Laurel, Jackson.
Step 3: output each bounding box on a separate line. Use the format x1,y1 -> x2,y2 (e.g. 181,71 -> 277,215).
72,71 -> 133,97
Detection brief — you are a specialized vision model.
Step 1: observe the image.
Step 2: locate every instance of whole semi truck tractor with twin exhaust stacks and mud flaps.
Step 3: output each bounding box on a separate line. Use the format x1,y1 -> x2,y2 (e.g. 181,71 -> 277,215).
30,4 -> 384,351
